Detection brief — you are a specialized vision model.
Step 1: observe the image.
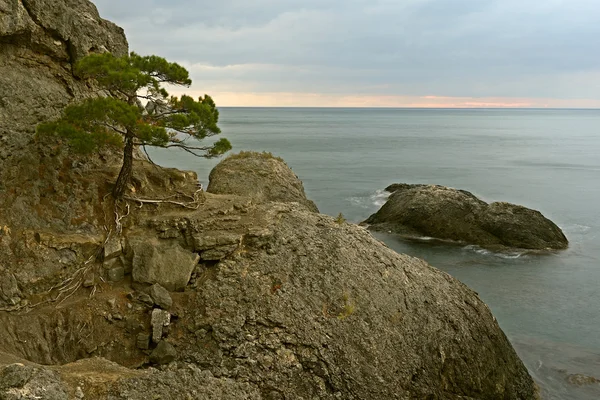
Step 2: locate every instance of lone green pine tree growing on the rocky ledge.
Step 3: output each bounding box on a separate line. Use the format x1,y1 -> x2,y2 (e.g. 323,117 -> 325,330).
37,53 -> 231,199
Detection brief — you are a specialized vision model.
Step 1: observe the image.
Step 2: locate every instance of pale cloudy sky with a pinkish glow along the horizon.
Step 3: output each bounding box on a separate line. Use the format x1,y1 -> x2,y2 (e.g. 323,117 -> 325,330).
93,0 -> 600,108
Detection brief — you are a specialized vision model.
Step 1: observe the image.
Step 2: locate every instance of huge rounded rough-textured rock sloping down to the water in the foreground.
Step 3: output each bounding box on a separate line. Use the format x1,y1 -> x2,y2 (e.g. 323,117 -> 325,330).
158,205 -> 537,399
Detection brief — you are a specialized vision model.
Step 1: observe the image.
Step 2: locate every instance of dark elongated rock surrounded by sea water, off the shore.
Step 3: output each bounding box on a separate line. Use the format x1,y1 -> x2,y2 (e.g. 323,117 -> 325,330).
364,184 -> 568,250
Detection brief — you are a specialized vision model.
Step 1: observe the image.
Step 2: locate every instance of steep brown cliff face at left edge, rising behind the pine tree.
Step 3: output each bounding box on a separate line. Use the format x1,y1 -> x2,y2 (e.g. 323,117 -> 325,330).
0,0 -> 127,307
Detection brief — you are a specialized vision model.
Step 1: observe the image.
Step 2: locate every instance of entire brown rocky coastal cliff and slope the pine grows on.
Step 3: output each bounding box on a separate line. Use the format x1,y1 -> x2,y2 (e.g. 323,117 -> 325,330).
0,0 -> 537,400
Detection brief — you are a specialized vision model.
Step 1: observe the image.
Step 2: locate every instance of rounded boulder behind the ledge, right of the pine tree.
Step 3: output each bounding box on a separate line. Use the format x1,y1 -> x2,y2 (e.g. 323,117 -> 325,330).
207,152 -> 319,212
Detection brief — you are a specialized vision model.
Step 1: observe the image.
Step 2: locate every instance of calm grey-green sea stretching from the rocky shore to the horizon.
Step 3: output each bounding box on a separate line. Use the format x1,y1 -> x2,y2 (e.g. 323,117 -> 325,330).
151,108 -> 600,400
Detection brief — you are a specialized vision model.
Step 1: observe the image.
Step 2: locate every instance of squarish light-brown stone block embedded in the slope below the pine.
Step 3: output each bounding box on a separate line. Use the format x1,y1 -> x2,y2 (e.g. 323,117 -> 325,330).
131,239 -> 200,291
